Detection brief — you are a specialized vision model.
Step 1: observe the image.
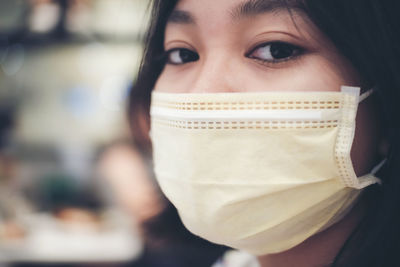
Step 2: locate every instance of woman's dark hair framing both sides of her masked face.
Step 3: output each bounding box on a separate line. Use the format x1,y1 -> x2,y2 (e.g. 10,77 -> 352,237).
129,0 -> 400,267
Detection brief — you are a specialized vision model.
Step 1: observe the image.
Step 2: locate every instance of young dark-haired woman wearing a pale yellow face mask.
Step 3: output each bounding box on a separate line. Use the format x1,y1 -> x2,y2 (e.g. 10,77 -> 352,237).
130,0 -> 400,267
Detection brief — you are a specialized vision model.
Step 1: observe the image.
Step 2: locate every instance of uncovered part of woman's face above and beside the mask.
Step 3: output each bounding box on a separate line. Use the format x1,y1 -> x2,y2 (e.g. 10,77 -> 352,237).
155,0 -> 377,175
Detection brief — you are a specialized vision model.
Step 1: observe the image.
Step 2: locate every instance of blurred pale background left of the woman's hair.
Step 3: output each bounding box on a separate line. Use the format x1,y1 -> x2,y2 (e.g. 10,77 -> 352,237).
0,0 -> 153,266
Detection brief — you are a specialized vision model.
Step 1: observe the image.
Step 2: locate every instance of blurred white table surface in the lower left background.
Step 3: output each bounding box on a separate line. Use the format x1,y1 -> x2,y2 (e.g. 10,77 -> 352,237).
0,210 -> 143,266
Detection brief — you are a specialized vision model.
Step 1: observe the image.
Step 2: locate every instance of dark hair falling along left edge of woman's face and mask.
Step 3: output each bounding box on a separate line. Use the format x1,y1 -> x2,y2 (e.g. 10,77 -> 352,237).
128,0 -> 229,260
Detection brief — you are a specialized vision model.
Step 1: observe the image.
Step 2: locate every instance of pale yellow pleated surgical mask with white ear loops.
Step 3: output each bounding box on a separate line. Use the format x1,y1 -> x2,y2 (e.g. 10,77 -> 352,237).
151,87 -> 379,255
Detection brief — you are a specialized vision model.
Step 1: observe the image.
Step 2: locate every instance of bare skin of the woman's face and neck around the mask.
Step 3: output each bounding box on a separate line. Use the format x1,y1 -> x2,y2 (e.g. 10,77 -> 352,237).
155,0 -> 380,267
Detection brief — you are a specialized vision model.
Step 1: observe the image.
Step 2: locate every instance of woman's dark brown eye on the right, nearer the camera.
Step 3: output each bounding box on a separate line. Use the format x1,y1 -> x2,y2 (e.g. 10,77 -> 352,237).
246,42 -> 303,63
